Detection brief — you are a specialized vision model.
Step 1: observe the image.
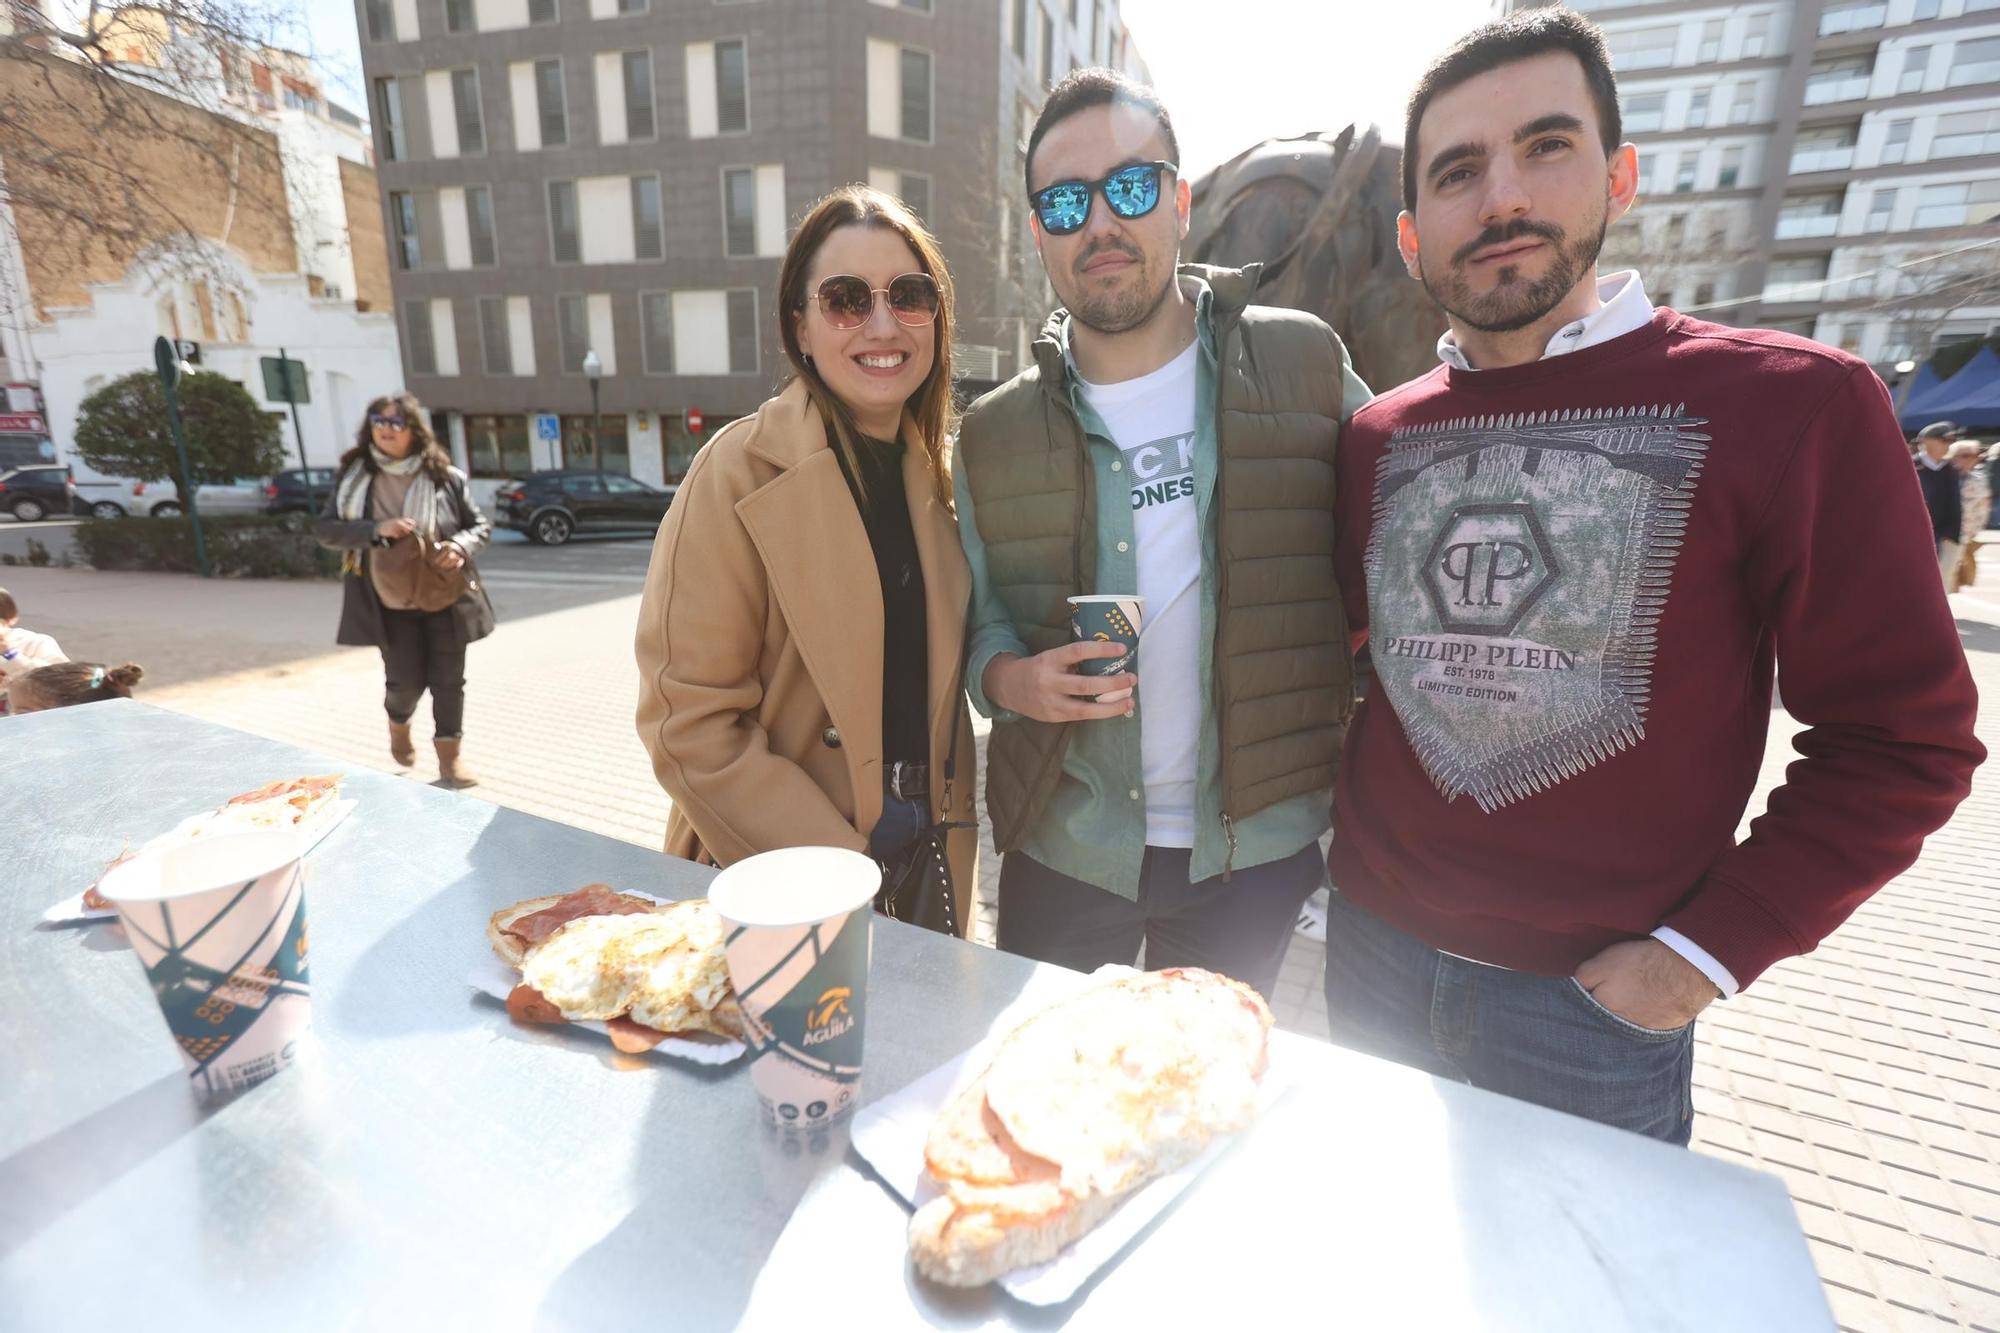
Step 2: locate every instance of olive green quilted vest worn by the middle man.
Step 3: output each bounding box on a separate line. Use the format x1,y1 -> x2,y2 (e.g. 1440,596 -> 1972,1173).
958,264 -> 1354,851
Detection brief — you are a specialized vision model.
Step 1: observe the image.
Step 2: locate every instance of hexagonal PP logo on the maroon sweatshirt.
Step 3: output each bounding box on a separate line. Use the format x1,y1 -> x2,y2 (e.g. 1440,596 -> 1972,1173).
1424,504 -> 1562,638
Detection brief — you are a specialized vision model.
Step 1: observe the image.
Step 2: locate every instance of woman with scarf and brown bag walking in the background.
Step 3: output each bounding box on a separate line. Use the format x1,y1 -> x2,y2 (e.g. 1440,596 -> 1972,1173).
316,392 -> 494,787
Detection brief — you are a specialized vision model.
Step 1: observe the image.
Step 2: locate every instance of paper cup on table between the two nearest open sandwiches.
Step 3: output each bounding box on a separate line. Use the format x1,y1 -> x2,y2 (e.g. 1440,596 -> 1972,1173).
708,847 -> 882,1127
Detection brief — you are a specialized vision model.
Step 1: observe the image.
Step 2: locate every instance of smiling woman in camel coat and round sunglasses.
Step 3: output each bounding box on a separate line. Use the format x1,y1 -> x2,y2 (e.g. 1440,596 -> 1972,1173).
638,186 -> 978,927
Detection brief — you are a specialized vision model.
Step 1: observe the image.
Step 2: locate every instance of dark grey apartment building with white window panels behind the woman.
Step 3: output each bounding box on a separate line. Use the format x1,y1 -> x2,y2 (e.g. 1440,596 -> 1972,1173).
360,0 -> 1142,500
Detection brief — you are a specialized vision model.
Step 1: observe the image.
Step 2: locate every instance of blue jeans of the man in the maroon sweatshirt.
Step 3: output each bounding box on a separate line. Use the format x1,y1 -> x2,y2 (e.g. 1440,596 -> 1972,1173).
1326,893 -> 1694,1147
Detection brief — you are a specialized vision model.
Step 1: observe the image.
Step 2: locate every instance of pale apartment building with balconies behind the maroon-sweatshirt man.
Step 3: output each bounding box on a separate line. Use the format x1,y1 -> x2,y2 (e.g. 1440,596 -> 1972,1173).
1502,0 -> 2000,368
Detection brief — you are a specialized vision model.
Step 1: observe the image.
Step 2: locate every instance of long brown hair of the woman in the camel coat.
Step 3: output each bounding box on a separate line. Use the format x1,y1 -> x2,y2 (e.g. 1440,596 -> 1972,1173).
778,184 -> 956,508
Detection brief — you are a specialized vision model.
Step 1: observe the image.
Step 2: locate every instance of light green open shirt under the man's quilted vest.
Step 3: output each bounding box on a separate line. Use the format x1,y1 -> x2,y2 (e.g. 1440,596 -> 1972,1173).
952,276 -> 1370,899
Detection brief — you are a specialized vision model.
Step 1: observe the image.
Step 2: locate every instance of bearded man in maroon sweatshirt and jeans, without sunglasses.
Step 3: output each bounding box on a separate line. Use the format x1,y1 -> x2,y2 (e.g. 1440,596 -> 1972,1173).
1326,8 -> 1984,1143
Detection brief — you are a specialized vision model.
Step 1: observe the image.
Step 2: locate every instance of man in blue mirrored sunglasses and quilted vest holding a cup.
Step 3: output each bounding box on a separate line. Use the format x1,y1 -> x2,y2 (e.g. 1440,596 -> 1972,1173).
952,70 -> 1368,995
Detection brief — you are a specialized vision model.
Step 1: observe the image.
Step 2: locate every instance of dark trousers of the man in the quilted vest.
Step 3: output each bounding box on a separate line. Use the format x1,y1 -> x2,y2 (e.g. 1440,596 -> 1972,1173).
1000,843 -> 1326,999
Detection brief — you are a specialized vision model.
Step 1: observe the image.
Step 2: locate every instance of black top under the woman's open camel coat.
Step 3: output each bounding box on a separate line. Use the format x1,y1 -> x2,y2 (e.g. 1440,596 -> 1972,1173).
856,436 -> 930,775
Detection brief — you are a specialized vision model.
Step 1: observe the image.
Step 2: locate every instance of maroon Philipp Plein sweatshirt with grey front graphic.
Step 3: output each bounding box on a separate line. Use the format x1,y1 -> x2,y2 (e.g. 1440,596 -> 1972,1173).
1330,310 -> 1986,985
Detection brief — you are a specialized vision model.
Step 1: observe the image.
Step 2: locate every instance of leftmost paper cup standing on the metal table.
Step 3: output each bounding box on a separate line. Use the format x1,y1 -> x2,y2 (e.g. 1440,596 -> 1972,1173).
98,831 -> 312,1097
